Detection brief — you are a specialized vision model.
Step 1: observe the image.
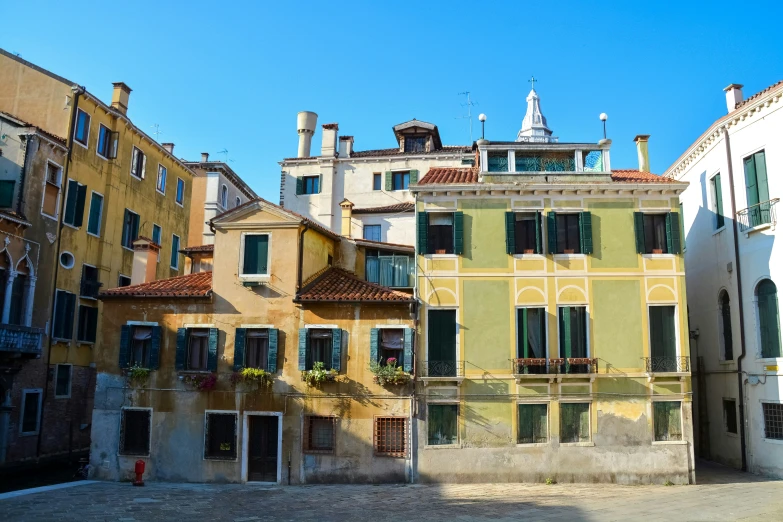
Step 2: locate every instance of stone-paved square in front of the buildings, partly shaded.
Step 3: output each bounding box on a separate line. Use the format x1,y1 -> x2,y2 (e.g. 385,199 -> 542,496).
0,466 -> 783,522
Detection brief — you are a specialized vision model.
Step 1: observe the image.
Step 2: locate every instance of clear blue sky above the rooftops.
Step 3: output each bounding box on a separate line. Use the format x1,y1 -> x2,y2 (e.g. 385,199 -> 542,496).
0,0 -> 783,201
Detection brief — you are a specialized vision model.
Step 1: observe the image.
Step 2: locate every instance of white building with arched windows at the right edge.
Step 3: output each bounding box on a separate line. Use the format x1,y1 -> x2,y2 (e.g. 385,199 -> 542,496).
664,82 -> 783,477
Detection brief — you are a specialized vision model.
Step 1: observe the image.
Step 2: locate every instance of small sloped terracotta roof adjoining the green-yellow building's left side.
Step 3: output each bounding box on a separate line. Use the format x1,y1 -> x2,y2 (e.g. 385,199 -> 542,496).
295,268 -> 413,303
